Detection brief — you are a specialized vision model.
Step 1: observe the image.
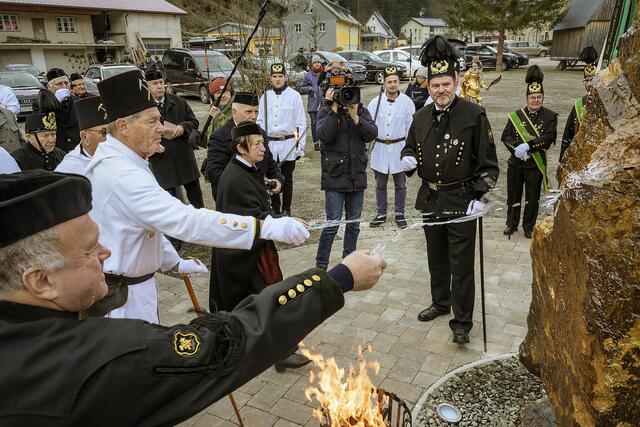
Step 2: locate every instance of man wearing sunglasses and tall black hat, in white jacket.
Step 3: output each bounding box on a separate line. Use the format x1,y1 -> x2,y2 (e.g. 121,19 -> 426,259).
56,96 -> 107,175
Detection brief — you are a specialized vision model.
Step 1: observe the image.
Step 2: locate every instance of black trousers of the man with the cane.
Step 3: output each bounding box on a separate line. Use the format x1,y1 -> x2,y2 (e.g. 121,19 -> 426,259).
424,221 -> 476,332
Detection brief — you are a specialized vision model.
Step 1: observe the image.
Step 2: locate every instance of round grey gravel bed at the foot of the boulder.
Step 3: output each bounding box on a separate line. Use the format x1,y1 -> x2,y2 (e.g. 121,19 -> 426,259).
414,356 -> 545,427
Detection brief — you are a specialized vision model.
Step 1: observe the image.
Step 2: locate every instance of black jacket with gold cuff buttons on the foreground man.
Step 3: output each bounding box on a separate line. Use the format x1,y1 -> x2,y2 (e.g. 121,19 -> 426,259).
0,269 -> 344,427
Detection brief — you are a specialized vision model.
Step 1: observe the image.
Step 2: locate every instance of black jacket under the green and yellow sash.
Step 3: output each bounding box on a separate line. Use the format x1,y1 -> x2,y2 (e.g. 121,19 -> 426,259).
502,107 -> 558,169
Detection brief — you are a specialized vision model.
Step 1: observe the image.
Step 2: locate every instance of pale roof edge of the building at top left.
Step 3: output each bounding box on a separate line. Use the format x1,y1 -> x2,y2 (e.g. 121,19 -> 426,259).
0,0 -> 187,15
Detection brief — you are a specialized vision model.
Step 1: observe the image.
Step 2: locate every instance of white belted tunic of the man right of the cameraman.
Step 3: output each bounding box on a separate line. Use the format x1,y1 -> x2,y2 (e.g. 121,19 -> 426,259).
367,93 -> 416,174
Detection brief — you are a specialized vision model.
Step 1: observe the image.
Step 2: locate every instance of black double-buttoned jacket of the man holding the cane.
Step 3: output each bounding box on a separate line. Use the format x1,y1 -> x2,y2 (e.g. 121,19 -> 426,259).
401,97 -> 500,218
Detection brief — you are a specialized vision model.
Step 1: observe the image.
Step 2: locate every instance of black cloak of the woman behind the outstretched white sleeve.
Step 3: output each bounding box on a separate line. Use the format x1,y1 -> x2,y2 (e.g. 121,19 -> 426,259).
210,157 -> 275,310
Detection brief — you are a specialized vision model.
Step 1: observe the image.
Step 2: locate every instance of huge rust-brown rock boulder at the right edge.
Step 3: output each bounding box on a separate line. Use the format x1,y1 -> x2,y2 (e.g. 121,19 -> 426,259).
520,15 -> 640,426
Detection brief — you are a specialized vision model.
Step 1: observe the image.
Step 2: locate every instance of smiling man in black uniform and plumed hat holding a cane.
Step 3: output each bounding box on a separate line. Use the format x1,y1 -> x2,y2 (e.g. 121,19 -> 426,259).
401,36 -> 499,344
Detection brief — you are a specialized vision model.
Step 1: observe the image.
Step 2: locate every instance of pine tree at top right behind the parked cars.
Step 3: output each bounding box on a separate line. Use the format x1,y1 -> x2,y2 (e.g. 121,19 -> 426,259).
447,0 -> 566,71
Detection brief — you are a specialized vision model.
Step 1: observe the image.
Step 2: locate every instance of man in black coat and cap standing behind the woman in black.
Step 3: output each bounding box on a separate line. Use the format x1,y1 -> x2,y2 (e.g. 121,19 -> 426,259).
206,92 -> 284,199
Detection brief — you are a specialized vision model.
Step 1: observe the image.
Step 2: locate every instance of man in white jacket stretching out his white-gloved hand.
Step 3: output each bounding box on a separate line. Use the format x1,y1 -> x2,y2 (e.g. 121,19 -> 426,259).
86,70 -> 309,323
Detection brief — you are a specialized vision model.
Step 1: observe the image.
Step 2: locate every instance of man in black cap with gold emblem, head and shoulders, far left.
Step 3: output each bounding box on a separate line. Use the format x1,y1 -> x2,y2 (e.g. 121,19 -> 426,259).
11,113 -> 65,171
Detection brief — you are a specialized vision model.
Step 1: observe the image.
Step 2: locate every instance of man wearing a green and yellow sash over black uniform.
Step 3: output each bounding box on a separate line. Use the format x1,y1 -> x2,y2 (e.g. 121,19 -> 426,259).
502,65 -> 558,239
